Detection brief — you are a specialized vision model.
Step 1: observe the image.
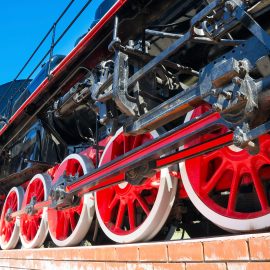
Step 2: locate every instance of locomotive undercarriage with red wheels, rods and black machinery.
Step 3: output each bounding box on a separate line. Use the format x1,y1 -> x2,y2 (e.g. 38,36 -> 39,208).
0,0 -> 270,249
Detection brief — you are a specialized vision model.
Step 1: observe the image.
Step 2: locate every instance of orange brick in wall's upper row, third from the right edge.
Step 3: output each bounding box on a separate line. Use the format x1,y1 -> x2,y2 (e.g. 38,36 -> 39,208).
168,242 -> 203,261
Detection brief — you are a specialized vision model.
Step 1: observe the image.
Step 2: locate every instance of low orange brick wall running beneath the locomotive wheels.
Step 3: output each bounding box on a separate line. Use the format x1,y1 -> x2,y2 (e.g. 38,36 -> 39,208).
0,234 -> 270,270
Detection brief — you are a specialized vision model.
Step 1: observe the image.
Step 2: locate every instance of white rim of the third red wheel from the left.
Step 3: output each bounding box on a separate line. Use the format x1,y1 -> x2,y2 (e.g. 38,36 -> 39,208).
48,154 -> 95,247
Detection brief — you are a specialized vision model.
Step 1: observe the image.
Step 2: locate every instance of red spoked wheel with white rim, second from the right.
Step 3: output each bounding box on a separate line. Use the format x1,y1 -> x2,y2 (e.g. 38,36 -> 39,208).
95,129 -> 177,243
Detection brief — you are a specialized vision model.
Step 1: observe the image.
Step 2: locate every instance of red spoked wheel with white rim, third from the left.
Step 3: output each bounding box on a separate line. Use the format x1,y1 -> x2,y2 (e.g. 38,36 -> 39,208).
48,154 -> 95,247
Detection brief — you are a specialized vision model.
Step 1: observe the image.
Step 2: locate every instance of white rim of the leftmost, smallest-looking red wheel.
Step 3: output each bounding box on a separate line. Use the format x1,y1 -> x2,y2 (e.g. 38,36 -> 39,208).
0,187 -> 24,249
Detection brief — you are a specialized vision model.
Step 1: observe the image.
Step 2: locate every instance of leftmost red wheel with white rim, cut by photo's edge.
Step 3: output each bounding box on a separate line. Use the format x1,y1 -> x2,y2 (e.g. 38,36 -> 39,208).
0,187 -> 24,249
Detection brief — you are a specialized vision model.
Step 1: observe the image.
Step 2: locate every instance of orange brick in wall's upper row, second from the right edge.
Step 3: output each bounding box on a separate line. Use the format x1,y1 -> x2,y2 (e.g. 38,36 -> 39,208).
204,239 -> 249,261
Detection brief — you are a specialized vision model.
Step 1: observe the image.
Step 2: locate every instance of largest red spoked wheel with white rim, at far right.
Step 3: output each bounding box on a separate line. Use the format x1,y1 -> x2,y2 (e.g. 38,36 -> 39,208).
180,106 -> 270,232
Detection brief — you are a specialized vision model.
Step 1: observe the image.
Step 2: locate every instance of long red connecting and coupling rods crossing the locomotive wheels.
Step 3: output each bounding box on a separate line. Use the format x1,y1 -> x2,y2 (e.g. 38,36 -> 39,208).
10,112 -> 233,217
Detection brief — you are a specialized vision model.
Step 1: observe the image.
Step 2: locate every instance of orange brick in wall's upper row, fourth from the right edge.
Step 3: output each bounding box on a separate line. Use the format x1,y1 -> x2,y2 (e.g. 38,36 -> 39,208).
139,244 -> 168,262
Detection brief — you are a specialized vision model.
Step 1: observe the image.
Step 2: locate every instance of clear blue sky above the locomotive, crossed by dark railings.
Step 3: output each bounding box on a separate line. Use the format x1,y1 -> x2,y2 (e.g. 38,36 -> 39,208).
0,0 -> 102,85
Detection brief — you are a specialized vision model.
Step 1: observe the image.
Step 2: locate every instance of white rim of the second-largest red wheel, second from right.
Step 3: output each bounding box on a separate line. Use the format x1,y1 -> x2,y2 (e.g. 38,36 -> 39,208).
95,128 -> 177,243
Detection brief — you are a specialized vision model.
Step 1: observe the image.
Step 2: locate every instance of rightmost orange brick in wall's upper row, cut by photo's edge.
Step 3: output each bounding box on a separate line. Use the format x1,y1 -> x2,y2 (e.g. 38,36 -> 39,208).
249,237 -> 270,260
